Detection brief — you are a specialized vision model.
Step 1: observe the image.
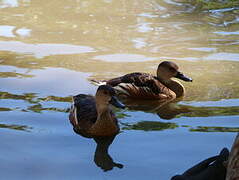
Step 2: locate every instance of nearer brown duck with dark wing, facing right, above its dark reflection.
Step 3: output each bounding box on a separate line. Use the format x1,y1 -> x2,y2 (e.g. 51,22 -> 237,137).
69,85 -> 125,138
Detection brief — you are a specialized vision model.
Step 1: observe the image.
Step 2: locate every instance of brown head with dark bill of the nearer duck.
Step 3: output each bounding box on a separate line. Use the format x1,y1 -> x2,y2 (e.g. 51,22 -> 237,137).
95,85 -> 125,109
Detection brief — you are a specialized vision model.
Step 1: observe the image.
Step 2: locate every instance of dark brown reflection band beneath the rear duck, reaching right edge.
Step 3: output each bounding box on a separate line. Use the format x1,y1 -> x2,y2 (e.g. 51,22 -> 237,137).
117,99 -> 239,120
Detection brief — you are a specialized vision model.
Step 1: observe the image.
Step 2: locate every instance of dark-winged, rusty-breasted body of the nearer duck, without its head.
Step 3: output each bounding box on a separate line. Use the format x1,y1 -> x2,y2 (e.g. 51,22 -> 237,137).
69,94 -> 119,138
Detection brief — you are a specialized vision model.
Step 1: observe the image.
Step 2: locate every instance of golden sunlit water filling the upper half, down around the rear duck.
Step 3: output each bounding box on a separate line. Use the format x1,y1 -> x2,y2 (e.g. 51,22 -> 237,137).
0,0 -> 239,100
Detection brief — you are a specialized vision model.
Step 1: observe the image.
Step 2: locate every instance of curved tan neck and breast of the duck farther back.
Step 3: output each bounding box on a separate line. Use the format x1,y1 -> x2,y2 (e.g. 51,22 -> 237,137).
158,77 -> 185,98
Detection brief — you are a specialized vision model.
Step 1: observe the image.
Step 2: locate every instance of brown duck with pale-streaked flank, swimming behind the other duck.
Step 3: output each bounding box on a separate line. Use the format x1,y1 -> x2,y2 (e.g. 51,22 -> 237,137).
91,61 -> 192,100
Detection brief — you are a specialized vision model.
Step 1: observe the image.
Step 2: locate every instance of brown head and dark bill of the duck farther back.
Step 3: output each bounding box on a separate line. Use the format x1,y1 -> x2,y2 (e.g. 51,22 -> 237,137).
157,61 -> 193,82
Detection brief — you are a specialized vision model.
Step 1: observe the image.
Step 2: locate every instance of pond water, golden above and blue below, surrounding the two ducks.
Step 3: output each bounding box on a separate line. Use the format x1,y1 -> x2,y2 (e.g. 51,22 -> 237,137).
0,0 -> 239,180
